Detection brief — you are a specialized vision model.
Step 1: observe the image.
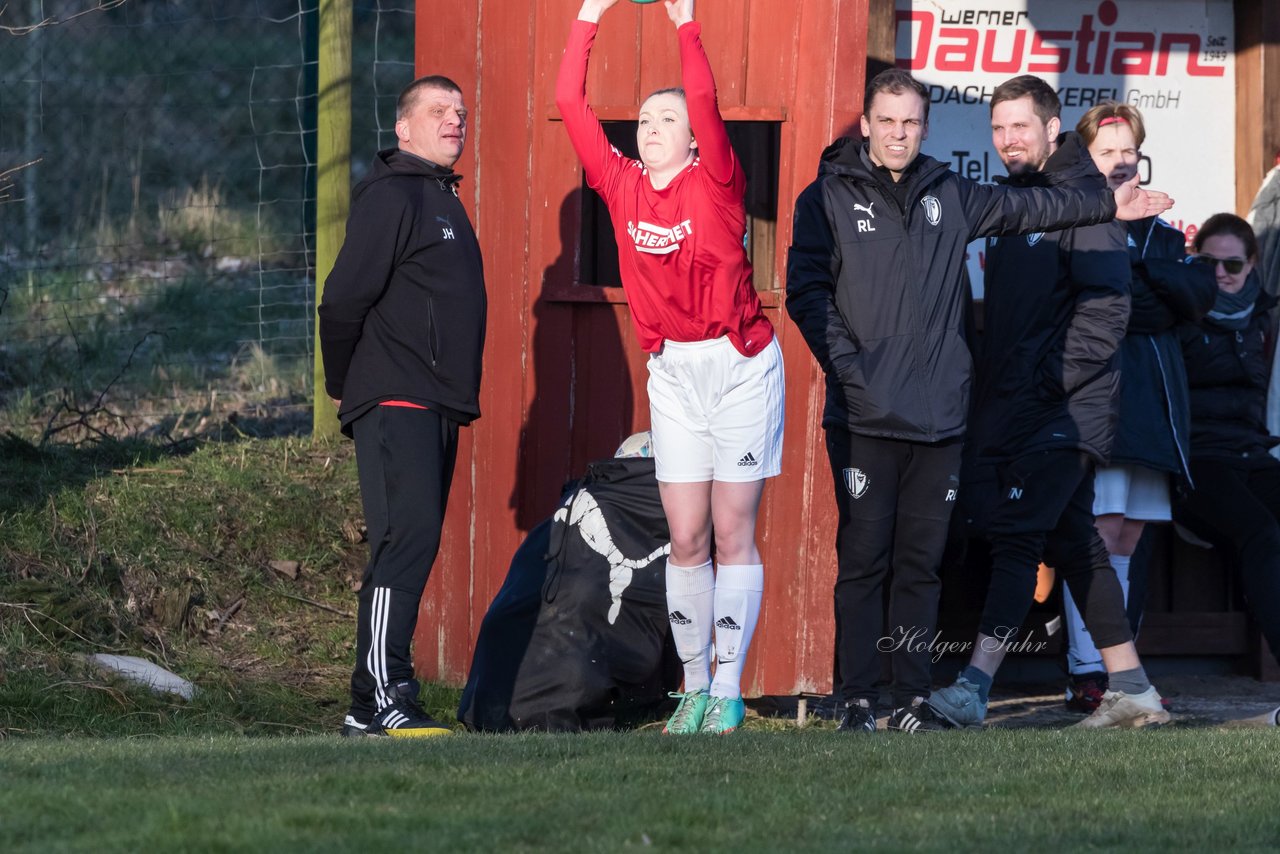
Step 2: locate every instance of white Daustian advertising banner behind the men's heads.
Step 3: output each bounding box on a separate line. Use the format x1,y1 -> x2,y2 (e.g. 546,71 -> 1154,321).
897,0 -> 1235,298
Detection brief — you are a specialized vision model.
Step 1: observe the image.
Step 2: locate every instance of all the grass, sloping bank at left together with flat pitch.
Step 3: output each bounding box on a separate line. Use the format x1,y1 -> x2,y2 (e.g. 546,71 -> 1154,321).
0,437 -> 1280,854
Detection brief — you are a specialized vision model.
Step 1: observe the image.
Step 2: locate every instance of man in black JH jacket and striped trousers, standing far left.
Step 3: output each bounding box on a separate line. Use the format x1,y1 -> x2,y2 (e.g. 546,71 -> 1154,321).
319,77 -> 486,737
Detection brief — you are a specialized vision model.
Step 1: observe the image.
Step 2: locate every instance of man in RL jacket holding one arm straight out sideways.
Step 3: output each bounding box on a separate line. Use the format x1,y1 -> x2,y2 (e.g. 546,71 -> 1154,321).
787,69 -> 1162,731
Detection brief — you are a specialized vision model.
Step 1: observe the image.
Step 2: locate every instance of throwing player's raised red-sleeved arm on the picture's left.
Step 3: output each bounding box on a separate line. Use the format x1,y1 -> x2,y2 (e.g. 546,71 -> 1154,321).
556,0 -> 620,187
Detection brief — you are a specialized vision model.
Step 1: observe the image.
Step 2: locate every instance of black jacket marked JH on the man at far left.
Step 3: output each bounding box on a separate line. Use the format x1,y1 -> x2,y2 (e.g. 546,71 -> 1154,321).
317,149 -> 488,435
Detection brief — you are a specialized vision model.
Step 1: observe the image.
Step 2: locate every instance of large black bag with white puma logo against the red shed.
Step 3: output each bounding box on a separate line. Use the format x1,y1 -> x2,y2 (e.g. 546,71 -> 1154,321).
458,458 -> 682,731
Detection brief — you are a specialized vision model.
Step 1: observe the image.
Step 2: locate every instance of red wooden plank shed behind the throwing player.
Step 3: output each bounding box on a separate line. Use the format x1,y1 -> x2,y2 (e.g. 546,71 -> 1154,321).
417,0 -> 892,694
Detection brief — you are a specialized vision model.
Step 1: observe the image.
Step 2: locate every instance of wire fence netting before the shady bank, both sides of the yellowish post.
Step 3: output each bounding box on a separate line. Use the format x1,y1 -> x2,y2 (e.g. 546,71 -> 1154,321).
0,0 -> 413,442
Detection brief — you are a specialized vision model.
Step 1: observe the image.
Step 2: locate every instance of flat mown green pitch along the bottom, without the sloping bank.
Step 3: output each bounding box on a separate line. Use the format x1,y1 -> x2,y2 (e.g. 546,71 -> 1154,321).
0,729 -> 1280,851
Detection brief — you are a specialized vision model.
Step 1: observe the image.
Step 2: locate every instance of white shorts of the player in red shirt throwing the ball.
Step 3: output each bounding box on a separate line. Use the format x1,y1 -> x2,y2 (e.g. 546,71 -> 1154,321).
649,337 -> 783,483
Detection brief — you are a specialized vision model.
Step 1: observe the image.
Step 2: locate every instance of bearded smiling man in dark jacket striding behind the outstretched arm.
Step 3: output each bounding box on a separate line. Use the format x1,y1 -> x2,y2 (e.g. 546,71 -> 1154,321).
929,76 -> 1169,729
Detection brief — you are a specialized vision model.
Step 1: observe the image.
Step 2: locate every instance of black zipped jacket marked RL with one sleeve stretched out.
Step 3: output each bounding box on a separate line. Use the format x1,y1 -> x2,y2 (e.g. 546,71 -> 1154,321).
787,140 -> 1115,442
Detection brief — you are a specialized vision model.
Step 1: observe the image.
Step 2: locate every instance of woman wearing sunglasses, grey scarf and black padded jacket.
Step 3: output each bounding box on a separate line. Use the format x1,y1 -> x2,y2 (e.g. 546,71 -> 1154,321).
1174,214 -> 1280,701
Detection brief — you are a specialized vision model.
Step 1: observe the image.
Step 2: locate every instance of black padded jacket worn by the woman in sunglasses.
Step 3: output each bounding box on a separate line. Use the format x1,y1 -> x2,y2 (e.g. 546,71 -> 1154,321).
1178,285 -> 1280,465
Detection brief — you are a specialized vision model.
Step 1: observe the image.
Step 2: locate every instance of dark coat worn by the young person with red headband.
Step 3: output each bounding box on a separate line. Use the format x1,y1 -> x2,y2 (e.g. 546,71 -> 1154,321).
1111,216 -> 1217,478
